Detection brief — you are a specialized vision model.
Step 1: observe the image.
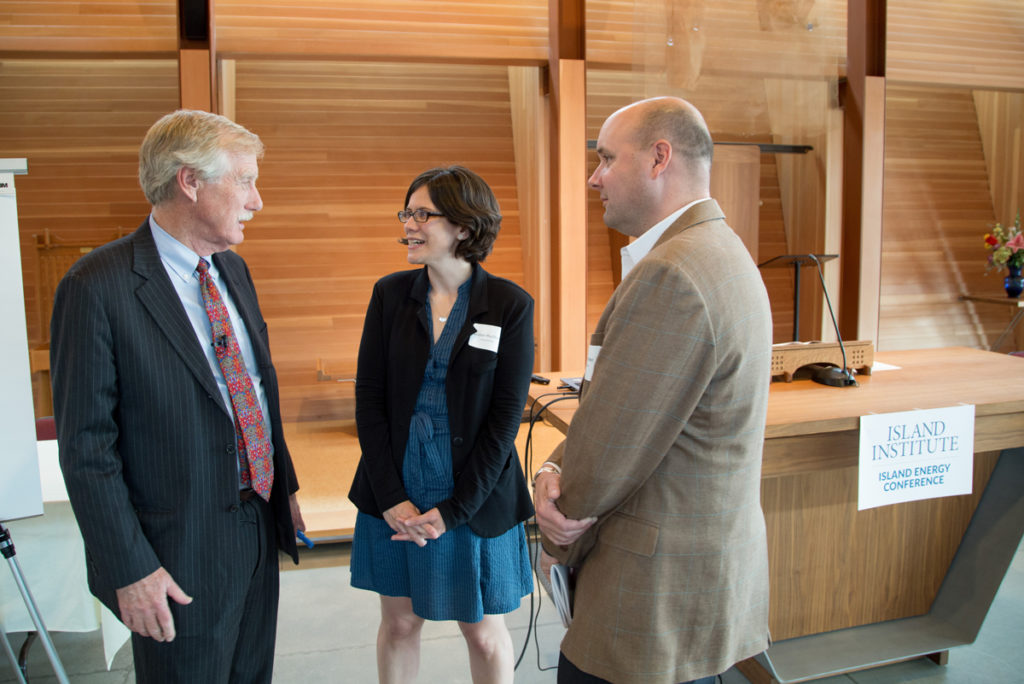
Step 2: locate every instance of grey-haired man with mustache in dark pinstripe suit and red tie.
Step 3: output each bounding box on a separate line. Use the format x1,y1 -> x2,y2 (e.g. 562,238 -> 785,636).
50,111 -> 304,683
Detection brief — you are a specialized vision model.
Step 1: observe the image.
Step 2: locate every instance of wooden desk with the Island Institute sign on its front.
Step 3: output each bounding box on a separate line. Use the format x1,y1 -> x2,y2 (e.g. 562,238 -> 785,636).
530,347 -> 1024,682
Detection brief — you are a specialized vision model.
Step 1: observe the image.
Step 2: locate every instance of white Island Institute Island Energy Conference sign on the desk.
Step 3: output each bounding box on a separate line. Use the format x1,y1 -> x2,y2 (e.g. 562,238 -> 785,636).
857,405 -> 974,511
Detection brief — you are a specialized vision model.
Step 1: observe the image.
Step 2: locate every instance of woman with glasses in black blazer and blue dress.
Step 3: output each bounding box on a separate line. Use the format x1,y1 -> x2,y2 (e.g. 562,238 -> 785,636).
348,166 -> 534,683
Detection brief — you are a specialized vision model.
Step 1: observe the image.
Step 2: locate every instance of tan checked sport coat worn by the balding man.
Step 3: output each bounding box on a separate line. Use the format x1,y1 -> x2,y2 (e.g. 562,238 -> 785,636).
545,202 -> 772,684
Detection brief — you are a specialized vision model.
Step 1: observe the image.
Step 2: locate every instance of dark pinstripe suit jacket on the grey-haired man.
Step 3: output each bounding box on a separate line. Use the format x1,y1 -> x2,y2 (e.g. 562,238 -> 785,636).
50,220 -> 298,618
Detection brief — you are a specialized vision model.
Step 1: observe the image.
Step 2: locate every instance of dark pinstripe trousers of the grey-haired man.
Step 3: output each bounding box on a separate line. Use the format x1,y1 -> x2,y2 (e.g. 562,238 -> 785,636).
131,497 -> 279,684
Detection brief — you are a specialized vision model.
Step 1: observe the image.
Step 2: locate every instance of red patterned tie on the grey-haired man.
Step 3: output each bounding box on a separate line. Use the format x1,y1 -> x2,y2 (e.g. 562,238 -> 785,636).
196,259 -> 273,501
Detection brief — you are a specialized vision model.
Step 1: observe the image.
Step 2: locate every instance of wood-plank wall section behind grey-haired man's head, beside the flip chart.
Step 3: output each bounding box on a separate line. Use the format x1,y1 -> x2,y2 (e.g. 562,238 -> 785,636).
0,59 -> 178,345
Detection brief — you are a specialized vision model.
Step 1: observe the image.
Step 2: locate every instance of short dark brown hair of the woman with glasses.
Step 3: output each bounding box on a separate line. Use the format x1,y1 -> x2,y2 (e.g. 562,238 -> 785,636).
406,166 -> 502,263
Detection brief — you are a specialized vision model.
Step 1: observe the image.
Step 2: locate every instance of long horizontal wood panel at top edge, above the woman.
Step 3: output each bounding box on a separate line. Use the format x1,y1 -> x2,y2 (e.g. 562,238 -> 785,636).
216,0 -> 548,65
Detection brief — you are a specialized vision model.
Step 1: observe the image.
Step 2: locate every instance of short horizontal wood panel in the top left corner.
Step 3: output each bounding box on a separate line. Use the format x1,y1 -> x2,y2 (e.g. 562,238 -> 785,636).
0,0 -> 178,54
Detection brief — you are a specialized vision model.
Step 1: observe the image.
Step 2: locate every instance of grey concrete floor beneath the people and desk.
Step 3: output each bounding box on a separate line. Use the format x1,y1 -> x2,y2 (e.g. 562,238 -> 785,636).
0,544 -> 1024,684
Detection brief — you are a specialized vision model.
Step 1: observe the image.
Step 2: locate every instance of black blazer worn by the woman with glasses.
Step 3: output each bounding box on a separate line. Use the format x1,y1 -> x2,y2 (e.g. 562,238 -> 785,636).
348,264 -> 534,537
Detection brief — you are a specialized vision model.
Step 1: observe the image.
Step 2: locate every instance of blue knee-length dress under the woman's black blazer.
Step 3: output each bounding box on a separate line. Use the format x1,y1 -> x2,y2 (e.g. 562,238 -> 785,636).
351,281 -> 534,623
